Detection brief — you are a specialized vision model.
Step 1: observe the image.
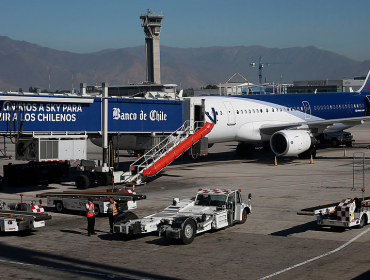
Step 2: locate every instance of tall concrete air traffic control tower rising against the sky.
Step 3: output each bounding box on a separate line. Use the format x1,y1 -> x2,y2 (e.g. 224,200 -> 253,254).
140,9 -> 164,84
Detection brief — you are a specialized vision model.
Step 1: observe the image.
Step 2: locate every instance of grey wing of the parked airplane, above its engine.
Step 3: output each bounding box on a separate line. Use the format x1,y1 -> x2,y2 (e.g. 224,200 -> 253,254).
260,116 -> 370,135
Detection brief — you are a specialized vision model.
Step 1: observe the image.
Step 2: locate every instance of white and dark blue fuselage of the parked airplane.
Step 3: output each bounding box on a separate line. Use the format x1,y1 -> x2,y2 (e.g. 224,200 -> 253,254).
194,93 -> 367,143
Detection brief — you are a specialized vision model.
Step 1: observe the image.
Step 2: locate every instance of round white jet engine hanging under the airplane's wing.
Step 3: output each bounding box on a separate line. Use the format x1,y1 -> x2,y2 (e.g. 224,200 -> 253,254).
270,130 -> 315,156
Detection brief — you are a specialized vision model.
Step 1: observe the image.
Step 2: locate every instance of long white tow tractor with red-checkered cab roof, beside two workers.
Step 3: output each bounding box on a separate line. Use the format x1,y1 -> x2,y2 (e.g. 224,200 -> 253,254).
114,189 -> 252,244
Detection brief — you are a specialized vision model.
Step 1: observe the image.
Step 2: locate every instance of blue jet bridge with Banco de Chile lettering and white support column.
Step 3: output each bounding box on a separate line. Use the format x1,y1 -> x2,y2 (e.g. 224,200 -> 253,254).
0,83 -> 208,187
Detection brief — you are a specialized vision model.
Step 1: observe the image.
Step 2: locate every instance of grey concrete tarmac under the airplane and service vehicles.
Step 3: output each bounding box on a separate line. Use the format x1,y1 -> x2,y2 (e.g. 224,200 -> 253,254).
0,124 -> 370,279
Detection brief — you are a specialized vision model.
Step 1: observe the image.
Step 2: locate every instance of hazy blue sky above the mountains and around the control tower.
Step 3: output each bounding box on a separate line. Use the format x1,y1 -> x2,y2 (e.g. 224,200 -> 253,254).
0,0 -> 370,61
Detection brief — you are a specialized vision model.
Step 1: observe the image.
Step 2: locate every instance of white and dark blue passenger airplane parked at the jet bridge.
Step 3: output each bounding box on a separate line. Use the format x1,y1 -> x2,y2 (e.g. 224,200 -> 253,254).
92,71 -> 370,160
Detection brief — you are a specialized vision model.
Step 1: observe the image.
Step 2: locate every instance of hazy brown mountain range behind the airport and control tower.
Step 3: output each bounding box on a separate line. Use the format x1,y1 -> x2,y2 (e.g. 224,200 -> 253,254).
0,36 -> 370,91
